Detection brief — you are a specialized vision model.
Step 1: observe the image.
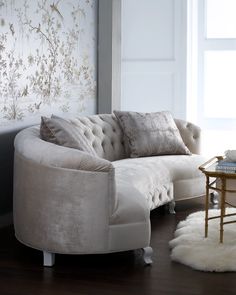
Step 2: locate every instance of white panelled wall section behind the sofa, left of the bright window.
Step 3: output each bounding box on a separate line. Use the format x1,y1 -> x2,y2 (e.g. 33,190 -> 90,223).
121,0 -> 186,119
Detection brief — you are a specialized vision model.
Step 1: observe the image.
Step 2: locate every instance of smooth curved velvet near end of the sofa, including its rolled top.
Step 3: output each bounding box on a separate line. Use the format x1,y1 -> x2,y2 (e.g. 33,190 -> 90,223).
13,127 -> 116,254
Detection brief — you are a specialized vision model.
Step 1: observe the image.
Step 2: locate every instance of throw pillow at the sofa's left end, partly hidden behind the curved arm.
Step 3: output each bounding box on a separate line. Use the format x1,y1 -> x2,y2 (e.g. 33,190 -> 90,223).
40,116 -> 97,156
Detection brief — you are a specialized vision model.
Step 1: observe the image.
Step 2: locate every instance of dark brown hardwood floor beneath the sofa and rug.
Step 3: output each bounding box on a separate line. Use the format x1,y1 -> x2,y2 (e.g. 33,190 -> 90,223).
0,199 -> 236,295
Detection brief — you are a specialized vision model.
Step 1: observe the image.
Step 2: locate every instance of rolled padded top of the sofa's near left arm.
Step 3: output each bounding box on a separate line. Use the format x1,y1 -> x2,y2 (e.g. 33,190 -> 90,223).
14,127 -> 114,172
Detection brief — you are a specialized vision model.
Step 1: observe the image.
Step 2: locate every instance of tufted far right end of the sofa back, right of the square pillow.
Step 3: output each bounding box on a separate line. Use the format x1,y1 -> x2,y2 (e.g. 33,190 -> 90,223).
175,119 -> 201,154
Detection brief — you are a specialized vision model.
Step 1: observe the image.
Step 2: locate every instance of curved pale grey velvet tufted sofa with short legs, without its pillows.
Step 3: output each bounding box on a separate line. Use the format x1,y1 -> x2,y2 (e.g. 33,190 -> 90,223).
14,114 -> 205,266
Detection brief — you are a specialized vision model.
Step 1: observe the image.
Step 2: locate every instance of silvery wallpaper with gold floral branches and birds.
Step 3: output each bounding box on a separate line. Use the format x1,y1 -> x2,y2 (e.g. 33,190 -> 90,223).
0,0 -> 97,126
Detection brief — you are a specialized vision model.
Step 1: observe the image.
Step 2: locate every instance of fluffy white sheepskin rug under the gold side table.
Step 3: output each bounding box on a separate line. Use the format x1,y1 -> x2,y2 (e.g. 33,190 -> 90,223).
169,208 -> 236,272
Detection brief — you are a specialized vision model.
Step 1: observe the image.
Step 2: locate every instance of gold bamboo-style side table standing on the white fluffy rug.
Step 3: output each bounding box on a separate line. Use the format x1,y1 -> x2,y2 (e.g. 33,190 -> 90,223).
199,156 -> 236,243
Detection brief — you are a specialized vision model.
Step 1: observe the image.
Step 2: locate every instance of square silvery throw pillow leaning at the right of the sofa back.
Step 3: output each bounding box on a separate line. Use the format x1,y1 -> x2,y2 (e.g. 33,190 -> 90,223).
114,111 -> 191,158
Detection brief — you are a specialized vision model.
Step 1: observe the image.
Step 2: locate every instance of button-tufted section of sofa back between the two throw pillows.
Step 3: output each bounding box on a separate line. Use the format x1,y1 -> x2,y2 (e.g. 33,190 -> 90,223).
70,114 -> 128,161
